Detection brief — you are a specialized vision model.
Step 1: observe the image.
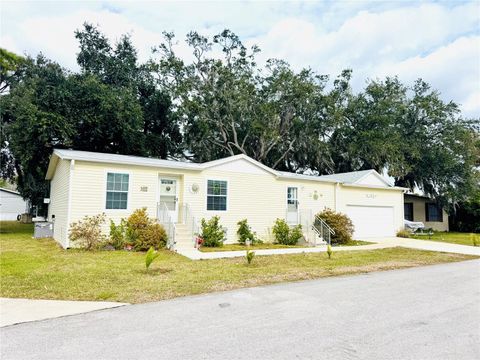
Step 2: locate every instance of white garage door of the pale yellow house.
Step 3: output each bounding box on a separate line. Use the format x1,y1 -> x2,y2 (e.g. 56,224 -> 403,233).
346,205 -> 395,239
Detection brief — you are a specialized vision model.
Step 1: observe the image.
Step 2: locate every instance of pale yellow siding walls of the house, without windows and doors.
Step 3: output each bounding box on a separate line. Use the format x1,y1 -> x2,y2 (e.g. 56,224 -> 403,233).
49,161 -> 403,246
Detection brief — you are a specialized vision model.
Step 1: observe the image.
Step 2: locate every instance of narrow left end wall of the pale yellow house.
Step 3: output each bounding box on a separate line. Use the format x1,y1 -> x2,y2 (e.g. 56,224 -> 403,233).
48,160 -> 70,247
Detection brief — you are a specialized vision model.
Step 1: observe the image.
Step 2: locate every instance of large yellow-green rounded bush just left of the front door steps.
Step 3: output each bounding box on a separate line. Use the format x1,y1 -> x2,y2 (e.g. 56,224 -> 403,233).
126,208 -> 167,251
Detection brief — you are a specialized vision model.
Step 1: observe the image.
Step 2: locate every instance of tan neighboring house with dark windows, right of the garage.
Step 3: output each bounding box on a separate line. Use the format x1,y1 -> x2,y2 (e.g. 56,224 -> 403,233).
404,194 -> 448,231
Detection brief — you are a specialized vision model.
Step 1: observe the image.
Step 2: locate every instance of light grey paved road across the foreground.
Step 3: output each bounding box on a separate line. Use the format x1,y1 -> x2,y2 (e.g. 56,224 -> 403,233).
1,260 -> 480,360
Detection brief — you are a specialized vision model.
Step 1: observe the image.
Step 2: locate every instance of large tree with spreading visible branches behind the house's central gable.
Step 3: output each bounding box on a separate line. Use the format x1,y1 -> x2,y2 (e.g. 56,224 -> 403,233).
152,30 -> 332,171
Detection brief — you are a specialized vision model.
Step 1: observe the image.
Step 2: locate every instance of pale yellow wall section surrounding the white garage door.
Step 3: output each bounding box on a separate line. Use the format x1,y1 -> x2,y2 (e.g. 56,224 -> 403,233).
337,185 -> 404,236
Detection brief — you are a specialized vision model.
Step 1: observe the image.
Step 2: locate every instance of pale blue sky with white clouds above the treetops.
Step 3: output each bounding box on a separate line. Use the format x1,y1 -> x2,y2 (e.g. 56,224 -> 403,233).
0,0 -> 480,118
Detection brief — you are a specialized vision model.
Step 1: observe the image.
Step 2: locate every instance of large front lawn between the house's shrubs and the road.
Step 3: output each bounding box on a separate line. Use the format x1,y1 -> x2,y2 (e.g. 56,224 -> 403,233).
0,223 -> 475,303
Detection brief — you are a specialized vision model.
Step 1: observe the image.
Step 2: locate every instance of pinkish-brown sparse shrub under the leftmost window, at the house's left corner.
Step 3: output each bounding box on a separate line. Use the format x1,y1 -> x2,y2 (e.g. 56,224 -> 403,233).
69,213 -> 107,250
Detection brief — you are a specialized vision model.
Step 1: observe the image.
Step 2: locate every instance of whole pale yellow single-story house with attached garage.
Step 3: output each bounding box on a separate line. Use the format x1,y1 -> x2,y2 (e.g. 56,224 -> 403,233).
46,149 -> 406,247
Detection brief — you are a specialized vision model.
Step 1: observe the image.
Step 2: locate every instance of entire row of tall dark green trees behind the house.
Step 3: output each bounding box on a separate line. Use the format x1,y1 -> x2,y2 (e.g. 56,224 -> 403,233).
0,24 -> 480,231
